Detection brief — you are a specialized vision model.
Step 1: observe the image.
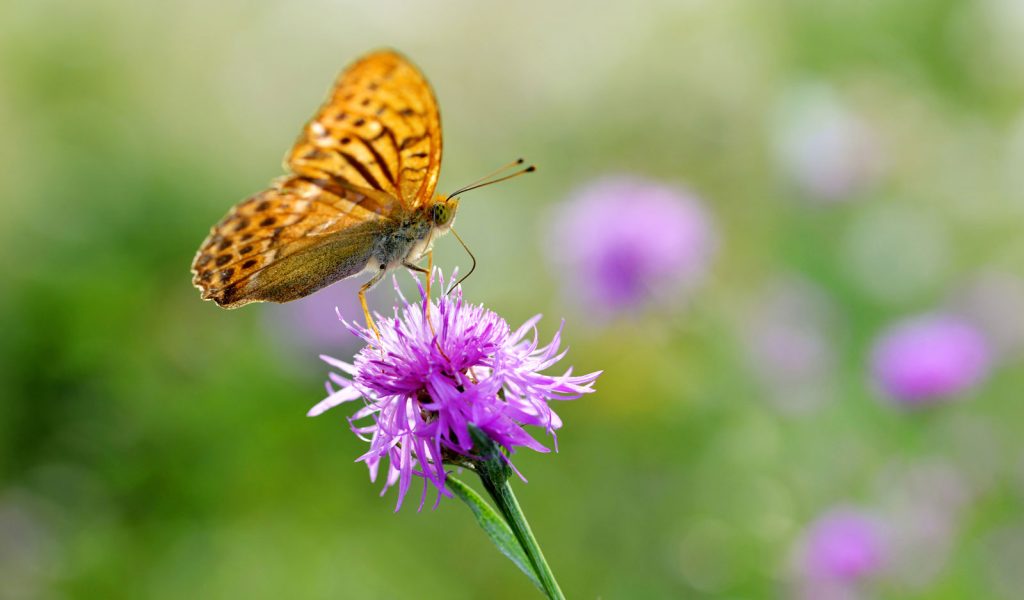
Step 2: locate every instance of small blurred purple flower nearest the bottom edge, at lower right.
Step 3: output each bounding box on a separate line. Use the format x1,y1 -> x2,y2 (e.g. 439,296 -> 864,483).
800,508 -> 886,584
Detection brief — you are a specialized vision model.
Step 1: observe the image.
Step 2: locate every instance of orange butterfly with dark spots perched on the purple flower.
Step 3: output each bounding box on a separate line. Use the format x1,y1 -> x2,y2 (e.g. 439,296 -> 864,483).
191,50 -> 534,331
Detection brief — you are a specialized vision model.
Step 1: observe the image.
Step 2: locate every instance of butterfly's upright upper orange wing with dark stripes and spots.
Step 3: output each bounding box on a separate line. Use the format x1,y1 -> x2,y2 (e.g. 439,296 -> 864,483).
286,50 -> 441,209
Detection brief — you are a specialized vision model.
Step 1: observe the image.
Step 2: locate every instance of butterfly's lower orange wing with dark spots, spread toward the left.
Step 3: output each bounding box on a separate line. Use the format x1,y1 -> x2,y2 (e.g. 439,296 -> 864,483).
191,177 -> 389,308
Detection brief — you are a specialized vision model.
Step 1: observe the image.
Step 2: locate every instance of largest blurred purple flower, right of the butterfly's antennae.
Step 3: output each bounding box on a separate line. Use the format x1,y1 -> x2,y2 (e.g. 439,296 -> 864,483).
551,176 -> 717,312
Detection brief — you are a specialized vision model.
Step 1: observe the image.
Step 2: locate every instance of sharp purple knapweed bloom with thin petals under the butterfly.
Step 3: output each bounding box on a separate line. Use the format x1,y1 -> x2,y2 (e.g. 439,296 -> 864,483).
309,270 -> 600,510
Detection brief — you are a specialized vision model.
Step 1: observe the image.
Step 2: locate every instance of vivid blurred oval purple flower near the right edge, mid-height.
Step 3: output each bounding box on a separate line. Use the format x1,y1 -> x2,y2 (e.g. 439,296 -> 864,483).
871,313 -> 990,405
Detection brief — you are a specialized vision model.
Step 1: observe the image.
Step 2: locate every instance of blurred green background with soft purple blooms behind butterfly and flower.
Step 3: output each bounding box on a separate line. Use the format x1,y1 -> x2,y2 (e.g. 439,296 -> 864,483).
0,0 -> 1024,599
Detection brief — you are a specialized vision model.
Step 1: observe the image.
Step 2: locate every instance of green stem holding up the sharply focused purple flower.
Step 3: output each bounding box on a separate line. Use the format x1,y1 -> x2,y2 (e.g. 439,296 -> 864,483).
470,426 -> 565,600
